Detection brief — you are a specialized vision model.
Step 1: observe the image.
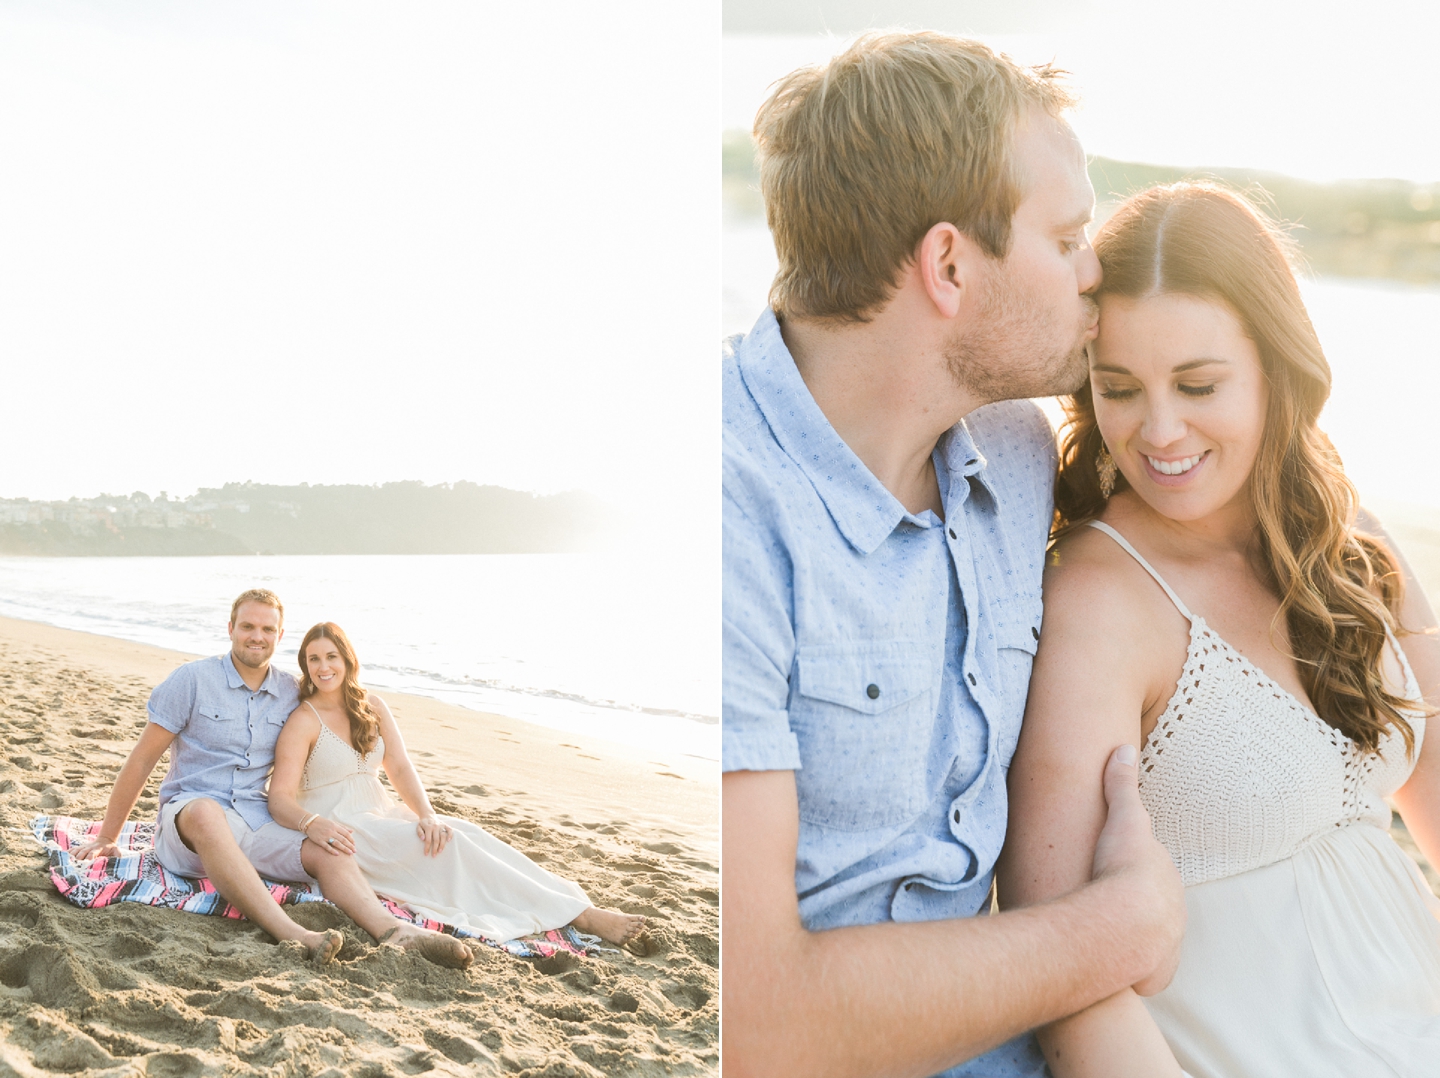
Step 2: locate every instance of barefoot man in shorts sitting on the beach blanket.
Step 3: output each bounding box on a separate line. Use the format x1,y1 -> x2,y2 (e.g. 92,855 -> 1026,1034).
73,589 -> 472,969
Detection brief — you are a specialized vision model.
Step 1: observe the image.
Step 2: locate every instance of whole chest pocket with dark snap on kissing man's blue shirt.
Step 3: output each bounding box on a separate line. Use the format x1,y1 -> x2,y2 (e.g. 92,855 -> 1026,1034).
789,642 -> 940,830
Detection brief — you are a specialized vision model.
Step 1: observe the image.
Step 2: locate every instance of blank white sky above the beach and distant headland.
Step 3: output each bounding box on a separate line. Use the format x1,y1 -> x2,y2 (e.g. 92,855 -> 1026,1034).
0,0 -> 720,532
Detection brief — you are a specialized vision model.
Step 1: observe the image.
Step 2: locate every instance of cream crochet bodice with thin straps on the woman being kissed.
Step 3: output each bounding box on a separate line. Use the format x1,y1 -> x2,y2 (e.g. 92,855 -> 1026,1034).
1092,521 -> 1424,887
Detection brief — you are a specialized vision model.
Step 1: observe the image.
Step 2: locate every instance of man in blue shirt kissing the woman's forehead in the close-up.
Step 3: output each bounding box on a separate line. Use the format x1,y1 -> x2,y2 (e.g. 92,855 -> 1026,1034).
721,33 -> 1184,1078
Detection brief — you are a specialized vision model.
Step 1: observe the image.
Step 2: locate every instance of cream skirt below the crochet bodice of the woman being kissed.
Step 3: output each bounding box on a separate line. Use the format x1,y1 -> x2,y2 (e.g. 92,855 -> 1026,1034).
1145,823 -> 1440,1078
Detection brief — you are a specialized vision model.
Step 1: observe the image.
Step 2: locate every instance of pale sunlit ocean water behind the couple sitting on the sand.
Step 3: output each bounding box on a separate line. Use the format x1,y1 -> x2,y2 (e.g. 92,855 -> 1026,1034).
0,550 -> 720,760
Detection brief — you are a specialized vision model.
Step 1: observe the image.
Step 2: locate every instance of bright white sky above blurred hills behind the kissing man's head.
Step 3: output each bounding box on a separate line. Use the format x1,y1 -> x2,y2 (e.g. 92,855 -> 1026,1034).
723,0 -> 1440,183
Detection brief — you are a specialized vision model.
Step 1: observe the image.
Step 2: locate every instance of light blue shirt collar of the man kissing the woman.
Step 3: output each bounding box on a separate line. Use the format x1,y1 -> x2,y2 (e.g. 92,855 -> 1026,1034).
736,308 -> 994,554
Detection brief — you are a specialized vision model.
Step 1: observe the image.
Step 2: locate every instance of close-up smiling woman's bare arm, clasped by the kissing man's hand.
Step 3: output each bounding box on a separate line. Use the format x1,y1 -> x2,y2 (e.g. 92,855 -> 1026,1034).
999,533 -> 1184,1078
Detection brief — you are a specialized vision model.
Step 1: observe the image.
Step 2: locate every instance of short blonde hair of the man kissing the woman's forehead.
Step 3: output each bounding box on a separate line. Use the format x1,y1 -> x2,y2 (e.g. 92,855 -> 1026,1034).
755,32 -> 1074,322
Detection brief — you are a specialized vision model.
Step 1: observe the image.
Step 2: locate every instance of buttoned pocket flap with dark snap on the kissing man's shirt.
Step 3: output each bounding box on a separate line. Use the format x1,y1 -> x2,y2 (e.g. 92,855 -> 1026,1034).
796,643 -> 939,715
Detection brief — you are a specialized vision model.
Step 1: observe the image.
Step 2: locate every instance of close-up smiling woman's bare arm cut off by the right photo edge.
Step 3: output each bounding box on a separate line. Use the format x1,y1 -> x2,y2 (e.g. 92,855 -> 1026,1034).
1356,509 -> 1440,869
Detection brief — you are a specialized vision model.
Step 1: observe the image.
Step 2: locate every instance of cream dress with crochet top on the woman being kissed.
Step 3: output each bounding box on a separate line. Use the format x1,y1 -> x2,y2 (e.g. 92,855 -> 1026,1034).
1093,521 -> 1440,1078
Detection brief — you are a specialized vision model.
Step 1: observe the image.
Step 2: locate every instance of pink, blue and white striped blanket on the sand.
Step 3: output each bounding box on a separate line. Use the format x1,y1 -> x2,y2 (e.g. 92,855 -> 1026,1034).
30,816 -> 590,959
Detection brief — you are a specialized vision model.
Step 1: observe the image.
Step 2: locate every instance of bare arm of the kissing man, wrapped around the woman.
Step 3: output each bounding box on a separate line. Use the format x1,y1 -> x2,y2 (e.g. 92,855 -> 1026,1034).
720,747 -> 1184,1078
